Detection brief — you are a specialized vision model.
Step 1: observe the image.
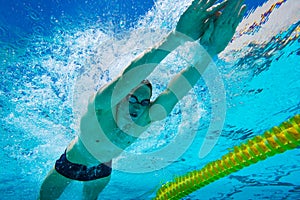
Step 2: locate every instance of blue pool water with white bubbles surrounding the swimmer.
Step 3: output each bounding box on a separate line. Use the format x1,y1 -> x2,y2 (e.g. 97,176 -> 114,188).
0,0 -> 300,200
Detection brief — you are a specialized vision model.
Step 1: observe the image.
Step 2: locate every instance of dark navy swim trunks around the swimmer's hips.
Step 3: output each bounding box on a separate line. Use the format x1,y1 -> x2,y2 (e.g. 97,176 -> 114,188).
55,152 -> 112,181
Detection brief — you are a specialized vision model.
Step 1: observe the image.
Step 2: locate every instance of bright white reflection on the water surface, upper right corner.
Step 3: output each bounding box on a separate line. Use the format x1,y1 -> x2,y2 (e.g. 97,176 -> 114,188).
226,0 -> 300,53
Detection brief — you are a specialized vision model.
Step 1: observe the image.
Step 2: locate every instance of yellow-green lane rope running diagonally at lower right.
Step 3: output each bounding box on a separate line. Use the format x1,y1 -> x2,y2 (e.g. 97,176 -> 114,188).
154,114 -> 300,200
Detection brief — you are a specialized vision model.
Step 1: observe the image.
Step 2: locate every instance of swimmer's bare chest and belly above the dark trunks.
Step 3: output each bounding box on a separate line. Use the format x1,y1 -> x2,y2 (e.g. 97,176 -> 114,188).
67,94 -> 148,166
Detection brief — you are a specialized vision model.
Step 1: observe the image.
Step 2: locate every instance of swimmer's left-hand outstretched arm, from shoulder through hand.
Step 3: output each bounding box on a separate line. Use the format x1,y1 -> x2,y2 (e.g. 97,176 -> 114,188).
95,0 -> 226,109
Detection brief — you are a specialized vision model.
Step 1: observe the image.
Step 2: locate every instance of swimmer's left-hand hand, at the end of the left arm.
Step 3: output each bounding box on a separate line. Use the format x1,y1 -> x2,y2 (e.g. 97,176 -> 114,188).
176,0 -> 228,40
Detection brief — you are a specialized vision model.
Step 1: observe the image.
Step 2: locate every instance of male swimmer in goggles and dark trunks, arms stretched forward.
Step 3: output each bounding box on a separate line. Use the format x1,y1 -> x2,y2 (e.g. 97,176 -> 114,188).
39,0 -> 245,200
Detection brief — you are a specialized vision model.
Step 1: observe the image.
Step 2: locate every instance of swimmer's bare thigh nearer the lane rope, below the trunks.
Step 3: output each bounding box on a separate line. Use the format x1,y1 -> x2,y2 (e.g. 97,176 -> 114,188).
83,175 -> 111,200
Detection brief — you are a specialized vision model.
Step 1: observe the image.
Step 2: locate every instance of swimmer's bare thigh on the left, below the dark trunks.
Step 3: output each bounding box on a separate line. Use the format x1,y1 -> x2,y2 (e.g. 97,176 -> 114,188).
39,168 -> 72,200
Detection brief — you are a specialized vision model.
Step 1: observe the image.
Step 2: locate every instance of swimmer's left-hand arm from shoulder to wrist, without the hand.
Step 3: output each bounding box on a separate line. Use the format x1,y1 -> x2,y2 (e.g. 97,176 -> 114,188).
95,31 -> 188,110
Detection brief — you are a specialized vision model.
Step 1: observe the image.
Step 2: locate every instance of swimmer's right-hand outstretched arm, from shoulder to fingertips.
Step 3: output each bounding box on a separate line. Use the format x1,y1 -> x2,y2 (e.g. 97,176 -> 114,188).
149,0 -> 246,121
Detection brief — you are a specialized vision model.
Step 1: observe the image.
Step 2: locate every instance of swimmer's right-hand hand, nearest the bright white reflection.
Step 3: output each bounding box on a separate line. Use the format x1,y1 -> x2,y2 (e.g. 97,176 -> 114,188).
200,0 -> 246,56
